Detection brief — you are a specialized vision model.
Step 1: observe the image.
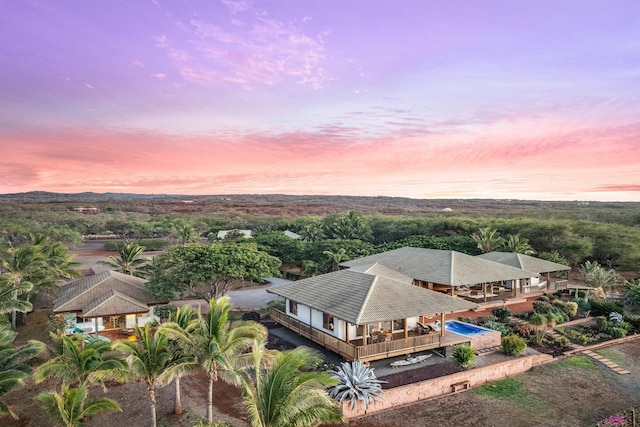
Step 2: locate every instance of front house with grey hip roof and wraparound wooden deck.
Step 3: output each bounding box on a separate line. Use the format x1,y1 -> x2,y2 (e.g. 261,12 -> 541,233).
268,263 -> 480,362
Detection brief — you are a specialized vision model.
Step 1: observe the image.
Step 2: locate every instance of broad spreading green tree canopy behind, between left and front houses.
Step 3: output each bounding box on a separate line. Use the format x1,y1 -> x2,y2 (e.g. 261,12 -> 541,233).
147,241 -> 281,299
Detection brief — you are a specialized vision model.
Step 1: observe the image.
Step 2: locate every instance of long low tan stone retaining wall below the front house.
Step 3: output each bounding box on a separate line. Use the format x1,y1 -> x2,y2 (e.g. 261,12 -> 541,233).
342,354 -> 553,419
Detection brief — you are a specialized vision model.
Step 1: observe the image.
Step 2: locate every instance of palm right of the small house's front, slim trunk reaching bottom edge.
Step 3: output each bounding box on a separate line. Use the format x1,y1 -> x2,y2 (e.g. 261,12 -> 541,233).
106,323 -> 188,427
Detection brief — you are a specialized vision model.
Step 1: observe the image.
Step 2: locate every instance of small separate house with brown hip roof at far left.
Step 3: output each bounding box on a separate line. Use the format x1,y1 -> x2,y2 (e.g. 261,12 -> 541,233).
53,271 -> 161,333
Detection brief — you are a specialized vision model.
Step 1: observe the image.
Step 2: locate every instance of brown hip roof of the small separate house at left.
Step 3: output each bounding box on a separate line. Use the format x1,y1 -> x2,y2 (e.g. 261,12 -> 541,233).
53,270 -> 160,317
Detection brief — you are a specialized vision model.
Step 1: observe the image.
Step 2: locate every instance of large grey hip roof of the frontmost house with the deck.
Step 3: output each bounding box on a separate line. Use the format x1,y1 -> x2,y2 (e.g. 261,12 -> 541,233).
267,266 -> 478,325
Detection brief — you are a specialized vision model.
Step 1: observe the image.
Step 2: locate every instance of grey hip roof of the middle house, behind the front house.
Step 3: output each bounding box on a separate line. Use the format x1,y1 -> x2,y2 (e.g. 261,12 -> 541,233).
340,247 -> 538,286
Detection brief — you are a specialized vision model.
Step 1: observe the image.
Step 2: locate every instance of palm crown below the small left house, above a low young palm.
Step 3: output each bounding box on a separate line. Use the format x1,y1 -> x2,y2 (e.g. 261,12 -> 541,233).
33,336 -> 126,387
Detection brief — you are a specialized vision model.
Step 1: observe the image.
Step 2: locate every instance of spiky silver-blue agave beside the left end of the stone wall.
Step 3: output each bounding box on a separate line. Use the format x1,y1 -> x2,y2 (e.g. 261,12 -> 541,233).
329,361 -> 386,412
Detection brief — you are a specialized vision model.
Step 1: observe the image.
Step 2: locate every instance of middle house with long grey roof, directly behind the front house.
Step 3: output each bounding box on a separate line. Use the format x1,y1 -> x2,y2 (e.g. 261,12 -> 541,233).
340,247 -> 538,302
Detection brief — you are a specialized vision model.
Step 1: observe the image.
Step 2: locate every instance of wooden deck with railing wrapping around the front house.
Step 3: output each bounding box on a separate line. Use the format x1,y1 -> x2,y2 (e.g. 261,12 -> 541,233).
269,308 -> 469,362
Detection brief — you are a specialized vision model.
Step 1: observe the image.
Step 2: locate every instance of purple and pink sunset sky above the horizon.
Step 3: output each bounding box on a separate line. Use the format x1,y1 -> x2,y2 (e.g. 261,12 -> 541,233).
0,0 -> 640,201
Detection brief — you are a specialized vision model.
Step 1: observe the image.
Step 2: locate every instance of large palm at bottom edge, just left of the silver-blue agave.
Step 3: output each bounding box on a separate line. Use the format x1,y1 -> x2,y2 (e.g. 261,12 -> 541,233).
240,340 -> 342,427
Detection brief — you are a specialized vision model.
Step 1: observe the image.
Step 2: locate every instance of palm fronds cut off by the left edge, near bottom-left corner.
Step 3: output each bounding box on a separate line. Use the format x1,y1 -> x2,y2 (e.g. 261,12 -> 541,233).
0,325 -> 46,418
